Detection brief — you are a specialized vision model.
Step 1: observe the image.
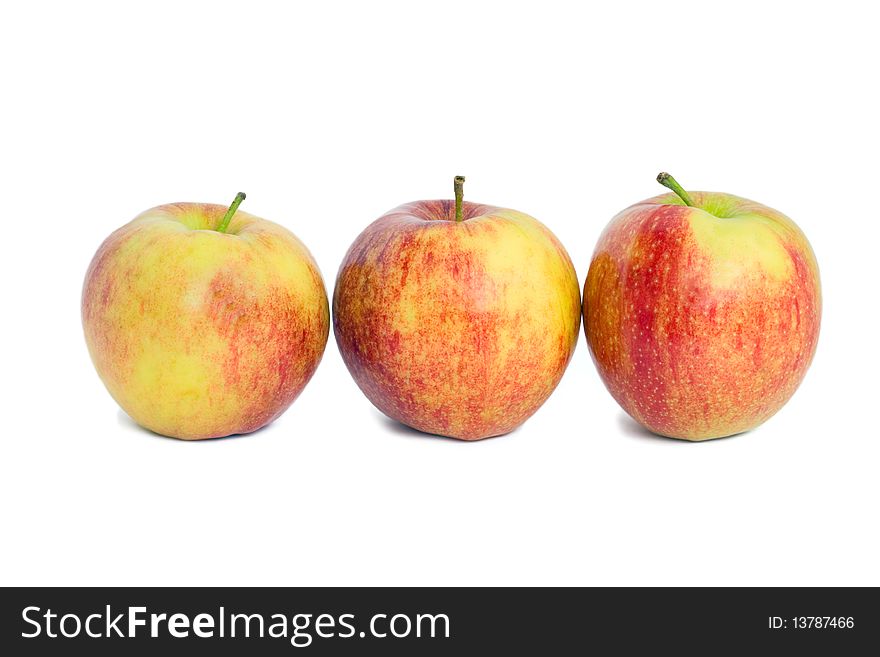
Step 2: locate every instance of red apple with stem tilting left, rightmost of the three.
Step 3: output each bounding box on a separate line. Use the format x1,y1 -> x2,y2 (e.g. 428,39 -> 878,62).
584,173 -> 822,440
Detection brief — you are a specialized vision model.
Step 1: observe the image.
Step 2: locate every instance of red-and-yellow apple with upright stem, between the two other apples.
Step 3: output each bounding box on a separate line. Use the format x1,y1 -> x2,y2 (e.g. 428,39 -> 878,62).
333,176 -> 580,440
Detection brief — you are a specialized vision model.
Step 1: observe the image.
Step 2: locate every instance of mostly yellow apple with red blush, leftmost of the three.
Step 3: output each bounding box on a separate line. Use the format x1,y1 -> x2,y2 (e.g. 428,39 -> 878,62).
82,194 -> 330,440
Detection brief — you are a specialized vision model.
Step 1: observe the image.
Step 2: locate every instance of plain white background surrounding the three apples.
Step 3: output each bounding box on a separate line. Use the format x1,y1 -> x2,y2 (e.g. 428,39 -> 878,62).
0,0 -> 880,585
